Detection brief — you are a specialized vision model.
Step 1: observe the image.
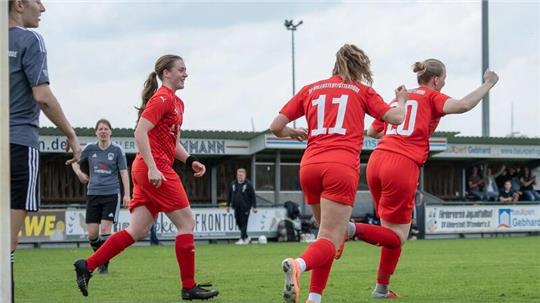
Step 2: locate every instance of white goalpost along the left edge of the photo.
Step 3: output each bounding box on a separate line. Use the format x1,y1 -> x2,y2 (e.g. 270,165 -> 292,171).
0,1 -> 11,302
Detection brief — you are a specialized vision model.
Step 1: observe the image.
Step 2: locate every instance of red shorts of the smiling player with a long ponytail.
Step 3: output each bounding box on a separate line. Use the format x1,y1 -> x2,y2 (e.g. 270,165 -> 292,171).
129,165 -> 189,218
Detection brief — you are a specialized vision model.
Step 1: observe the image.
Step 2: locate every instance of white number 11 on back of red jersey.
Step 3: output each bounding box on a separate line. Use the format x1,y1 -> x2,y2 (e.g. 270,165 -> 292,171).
311,95 -> 349,136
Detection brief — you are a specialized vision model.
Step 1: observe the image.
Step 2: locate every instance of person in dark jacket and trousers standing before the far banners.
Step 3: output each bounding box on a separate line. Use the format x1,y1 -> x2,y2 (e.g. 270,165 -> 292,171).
227,168 -> 257,245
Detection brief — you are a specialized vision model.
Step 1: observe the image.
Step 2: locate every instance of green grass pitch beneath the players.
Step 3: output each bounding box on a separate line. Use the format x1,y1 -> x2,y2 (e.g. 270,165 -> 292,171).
15,237 -> 540,303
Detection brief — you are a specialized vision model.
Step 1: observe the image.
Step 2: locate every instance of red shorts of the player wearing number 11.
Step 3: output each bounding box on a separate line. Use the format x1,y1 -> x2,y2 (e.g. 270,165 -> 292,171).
300,163 -> 359,206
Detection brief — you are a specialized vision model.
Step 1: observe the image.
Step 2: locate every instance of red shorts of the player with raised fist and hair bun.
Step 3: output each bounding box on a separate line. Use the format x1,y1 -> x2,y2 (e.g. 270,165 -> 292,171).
366,150 -> 420,224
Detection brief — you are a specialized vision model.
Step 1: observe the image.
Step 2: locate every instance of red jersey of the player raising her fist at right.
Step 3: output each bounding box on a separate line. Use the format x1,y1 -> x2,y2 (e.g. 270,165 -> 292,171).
371,86 -> 450,166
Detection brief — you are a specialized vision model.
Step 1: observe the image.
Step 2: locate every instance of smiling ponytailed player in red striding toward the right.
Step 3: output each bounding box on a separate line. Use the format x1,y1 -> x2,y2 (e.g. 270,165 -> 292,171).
74,55 -> 218,300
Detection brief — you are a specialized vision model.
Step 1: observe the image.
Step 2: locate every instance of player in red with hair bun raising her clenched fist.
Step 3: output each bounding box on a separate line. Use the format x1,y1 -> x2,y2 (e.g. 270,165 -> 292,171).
349,59 -> 499,298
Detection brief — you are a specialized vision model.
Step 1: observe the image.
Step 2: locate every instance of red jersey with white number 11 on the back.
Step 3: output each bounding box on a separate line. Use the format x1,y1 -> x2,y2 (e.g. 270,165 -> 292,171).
280,76 -> 390,169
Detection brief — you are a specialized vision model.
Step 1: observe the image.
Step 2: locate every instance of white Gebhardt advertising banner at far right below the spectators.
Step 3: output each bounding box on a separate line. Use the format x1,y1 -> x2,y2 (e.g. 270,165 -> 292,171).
425,205 -> 540,234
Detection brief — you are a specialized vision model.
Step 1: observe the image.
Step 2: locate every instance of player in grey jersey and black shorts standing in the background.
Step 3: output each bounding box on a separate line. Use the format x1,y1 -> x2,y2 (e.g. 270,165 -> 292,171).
71,119 -> 131,274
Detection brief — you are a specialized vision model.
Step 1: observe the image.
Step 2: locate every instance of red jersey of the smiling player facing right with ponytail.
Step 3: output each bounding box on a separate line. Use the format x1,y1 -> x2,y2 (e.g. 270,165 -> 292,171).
134,86 -> 184,170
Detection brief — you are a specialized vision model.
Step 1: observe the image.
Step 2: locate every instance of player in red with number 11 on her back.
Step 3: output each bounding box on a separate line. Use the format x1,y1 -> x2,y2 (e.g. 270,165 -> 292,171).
270,44 -> 407,302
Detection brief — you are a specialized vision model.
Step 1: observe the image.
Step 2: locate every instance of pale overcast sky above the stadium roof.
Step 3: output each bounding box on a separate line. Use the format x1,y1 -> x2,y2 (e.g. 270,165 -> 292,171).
38,0 -> 540,137
